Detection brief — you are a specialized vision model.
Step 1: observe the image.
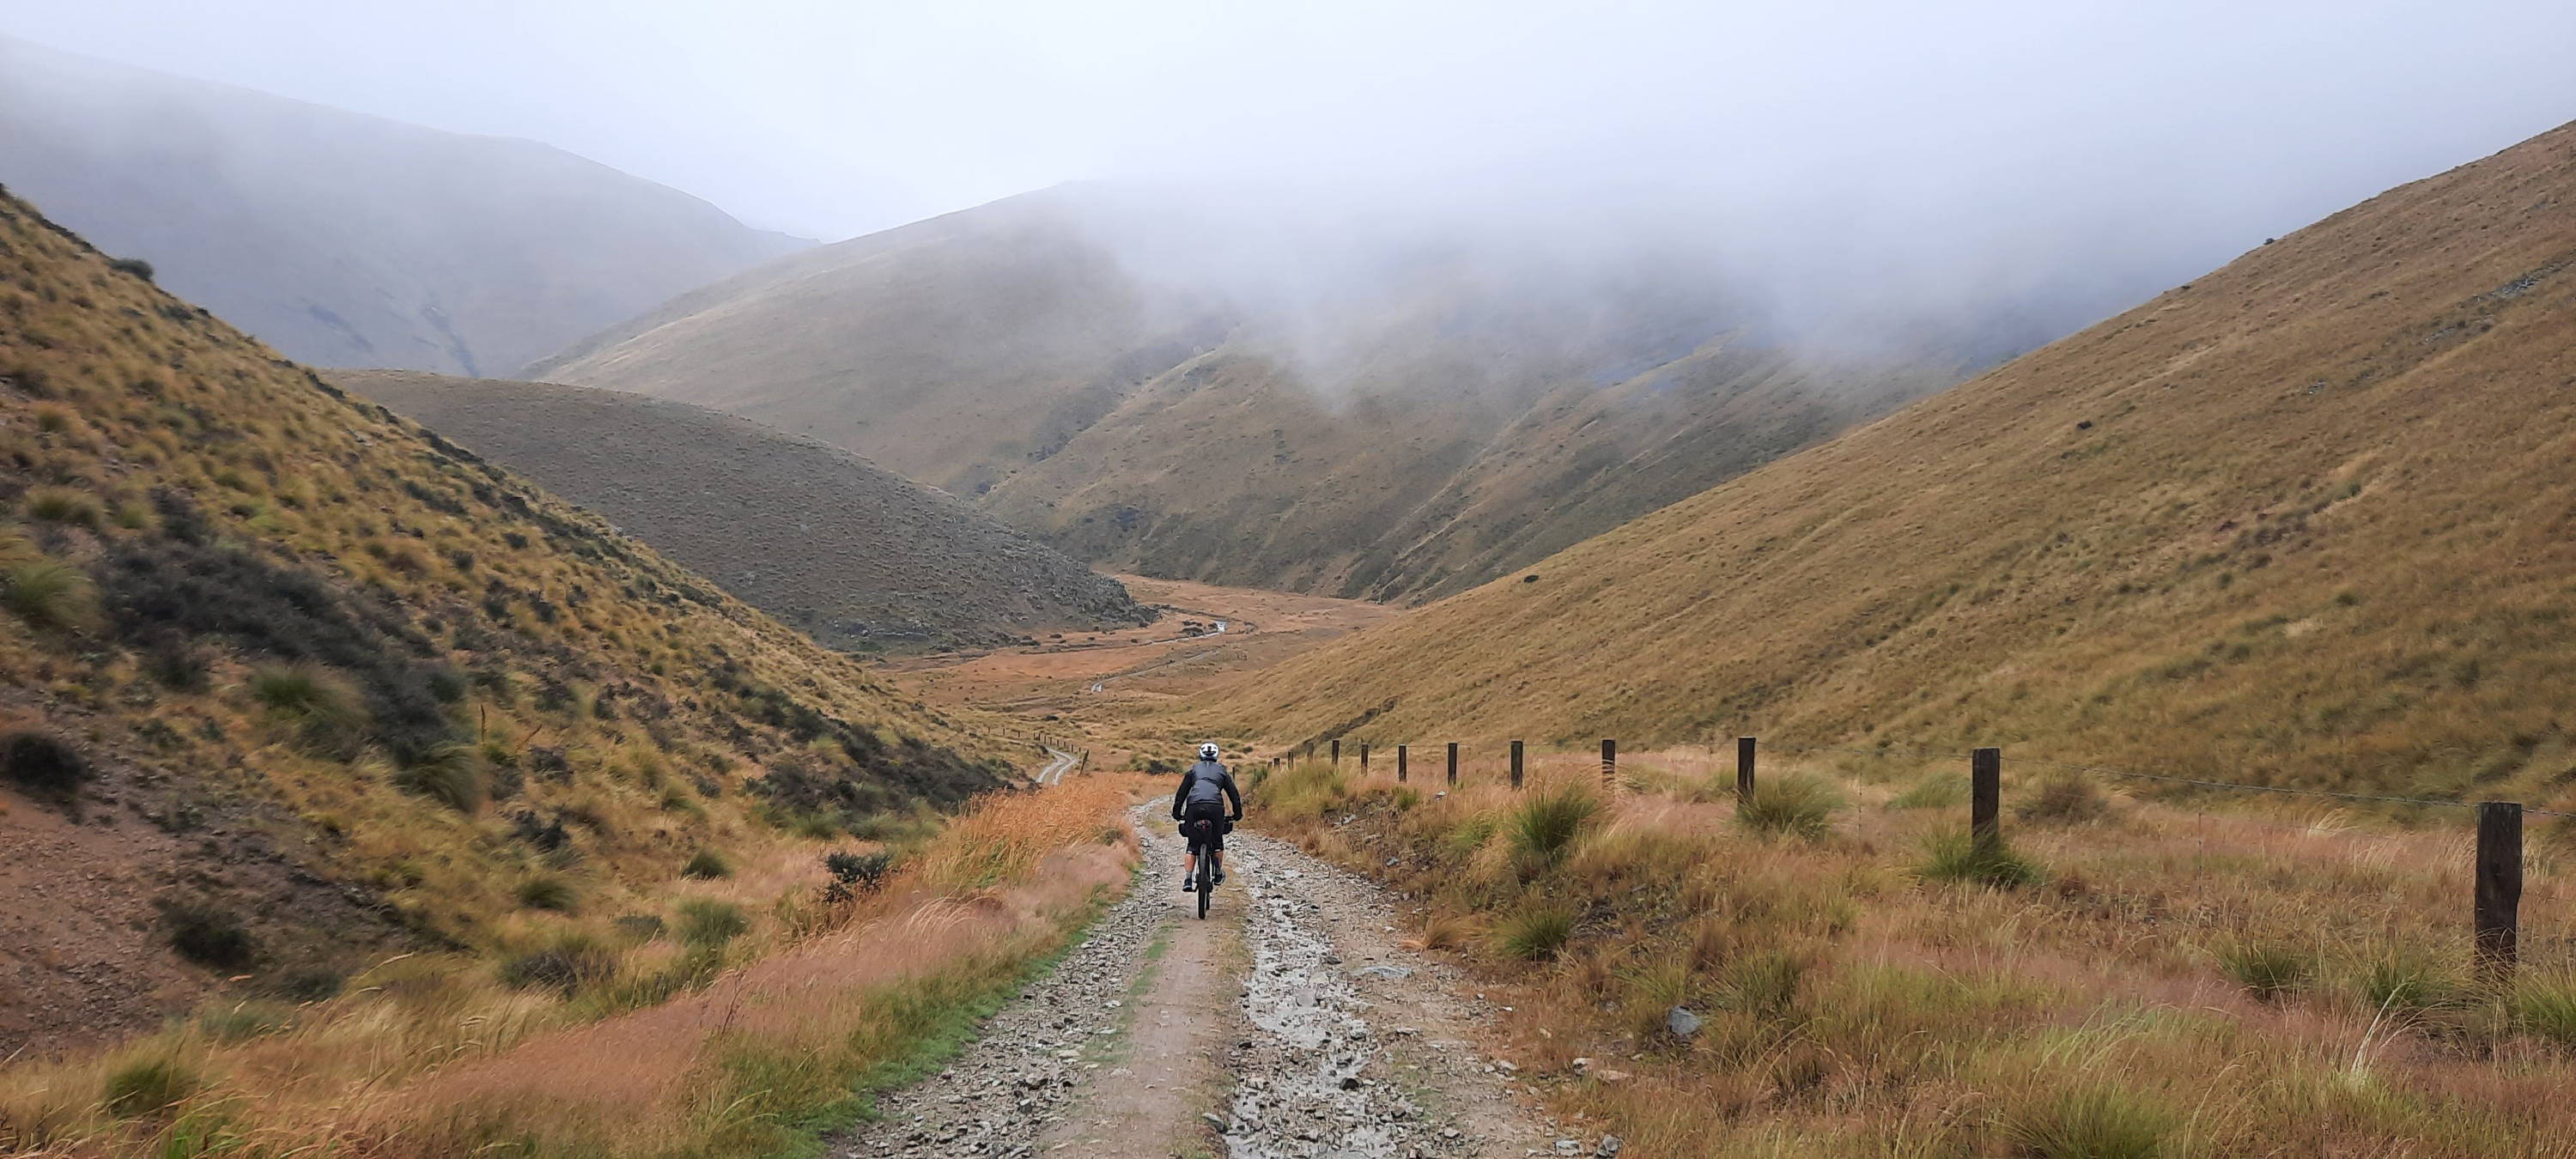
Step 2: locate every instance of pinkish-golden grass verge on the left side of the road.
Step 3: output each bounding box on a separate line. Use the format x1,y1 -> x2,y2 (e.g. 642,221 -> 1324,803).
0,778 -> 1136,1159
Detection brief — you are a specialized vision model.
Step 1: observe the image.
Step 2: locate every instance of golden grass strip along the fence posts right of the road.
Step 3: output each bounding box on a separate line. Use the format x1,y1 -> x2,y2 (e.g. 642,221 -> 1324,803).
1255,749 -> 2576,1156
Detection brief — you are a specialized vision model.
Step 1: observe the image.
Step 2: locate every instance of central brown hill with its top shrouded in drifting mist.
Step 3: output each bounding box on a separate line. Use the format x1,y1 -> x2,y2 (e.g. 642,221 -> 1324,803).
528,185 -> 1984,600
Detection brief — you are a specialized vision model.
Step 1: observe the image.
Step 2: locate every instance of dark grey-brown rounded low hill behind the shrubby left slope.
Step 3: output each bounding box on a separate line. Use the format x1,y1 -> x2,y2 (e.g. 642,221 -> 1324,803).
330,371 -> 1151,652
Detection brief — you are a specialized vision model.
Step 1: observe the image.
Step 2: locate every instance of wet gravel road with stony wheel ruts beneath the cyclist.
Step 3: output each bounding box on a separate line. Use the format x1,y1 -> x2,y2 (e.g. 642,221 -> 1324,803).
832,806 -> 1566,1159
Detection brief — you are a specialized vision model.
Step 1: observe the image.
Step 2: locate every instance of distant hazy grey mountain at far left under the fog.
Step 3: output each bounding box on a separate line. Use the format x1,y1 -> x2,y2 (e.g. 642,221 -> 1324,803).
0,39 -> 804,373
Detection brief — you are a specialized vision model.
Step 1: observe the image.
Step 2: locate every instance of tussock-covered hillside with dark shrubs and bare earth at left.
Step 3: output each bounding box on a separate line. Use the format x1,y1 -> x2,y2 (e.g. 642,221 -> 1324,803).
0,183 -> 1020,1056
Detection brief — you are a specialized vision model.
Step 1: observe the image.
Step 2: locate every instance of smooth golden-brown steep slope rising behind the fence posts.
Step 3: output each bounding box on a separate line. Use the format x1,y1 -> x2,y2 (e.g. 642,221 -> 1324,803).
1198,126 -> 2576,798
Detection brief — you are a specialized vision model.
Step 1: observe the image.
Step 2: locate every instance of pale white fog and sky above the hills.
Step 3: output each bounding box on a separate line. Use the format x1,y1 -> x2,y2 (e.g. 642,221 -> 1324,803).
0,0 -> 2576,353
